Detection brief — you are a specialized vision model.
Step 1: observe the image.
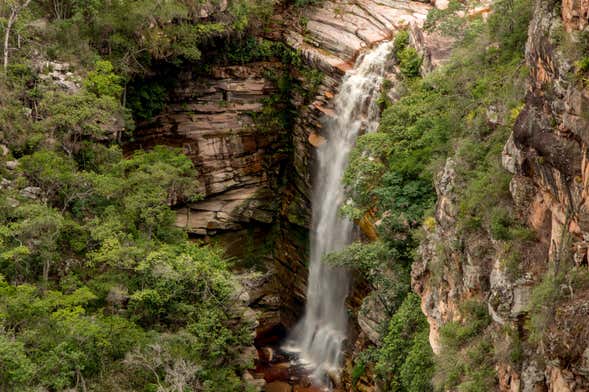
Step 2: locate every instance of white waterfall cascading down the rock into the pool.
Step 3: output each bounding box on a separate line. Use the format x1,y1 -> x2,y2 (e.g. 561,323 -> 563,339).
285,42 -> 392,385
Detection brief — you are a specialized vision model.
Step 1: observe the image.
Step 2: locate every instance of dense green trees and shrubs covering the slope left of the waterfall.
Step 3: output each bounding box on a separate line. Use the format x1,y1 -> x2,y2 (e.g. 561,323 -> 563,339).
0,0 -> 272,391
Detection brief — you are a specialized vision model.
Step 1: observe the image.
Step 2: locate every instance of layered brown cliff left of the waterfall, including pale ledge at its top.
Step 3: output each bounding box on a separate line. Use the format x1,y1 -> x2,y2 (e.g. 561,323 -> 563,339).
126,1 -> 449,344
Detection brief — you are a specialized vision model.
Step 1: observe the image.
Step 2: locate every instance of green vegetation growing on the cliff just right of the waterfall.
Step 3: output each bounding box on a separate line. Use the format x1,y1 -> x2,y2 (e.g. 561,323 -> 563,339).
331,0 -> 531,391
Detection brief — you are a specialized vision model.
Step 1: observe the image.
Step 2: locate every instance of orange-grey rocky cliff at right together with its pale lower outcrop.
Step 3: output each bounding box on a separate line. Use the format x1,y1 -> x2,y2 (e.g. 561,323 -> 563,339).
412,0 -> 589,391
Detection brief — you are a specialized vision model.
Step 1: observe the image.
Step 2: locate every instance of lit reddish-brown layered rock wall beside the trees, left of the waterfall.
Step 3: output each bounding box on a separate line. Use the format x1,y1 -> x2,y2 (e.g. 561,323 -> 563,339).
135,63 -> 287,236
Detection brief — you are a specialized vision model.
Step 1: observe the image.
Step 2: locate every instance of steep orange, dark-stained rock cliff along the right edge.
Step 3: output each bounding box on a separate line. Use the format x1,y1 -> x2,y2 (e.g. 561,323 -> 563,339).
506,1 -> 589,391
